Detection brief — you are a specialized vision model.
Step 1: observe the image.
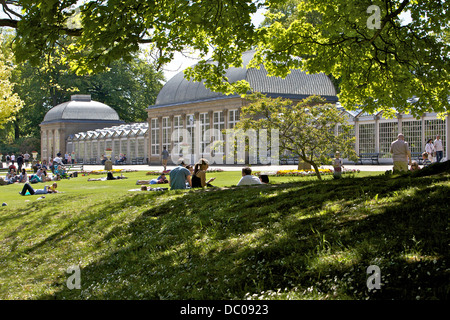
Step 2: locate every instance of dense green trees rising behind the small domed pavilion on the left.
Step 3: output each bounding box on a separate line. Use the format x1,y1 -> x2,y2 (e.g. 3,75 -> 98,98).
0,30 -> 164,153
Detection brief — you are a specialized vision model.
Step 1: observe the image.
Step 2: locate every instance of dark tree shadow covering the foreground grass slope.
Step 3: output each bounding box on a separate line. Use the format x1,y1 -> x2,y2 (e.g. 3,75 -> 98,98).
31,171 -> 450,300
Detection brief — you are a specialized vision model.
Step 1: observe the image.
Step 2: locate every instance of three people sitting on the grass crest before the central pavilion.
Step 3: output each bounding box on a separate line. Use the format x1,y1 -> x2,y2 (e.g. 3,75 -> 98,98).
168,158 -> 269,190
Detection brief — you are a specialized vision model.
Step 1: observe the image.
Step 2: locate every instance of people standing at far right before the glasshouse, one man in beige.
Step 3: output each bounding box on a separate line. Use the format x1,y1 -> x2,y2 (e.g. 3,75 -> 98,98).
390,133 -> 444,172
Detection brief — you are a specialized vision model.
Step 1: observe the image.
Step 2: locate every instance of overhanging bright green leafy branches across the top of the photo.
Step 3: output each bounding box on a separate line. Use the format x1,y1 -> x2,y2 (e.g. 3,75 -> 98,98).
0,0 -> 450,116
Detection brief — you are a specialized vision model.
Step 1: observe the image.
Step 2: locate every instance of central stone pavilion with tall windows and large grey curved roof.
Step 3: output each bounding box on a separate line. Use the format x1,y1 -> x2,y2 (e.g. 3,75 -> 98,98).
147,51 -> 338,164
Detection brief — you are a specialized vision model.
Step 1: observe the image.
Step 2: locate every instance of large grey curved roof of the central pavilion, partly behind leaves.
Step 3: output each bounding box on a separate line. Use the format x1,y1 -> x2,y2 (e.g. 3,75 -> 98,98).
150,50 -> 338,108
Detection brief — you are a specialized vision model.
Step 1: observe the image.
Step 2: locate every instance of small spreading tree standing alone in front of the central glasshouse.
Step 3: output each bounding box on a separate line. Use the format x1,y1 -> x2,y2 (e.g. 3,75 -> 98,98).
237,94 -> 357,179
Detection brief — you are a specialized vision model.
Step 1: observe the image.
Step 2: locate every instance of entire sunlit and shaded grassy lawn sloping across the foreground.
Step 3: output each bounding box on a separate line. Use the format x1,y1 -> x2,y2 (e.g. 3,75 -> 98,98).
0,169 -> 450,299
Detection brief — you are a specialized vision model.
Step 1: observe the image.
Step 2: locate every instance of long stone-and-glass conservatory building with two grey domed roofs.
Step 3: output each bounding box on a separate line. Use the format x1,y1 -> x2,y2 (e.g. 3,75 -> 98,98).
41,51 -> 450,165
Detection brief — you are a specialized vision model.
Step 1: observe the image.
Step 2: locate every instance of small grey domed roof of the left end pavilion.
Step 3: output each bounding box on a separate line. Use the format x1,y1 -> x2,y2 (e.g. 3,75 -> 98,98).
42,95 -> 121,124
